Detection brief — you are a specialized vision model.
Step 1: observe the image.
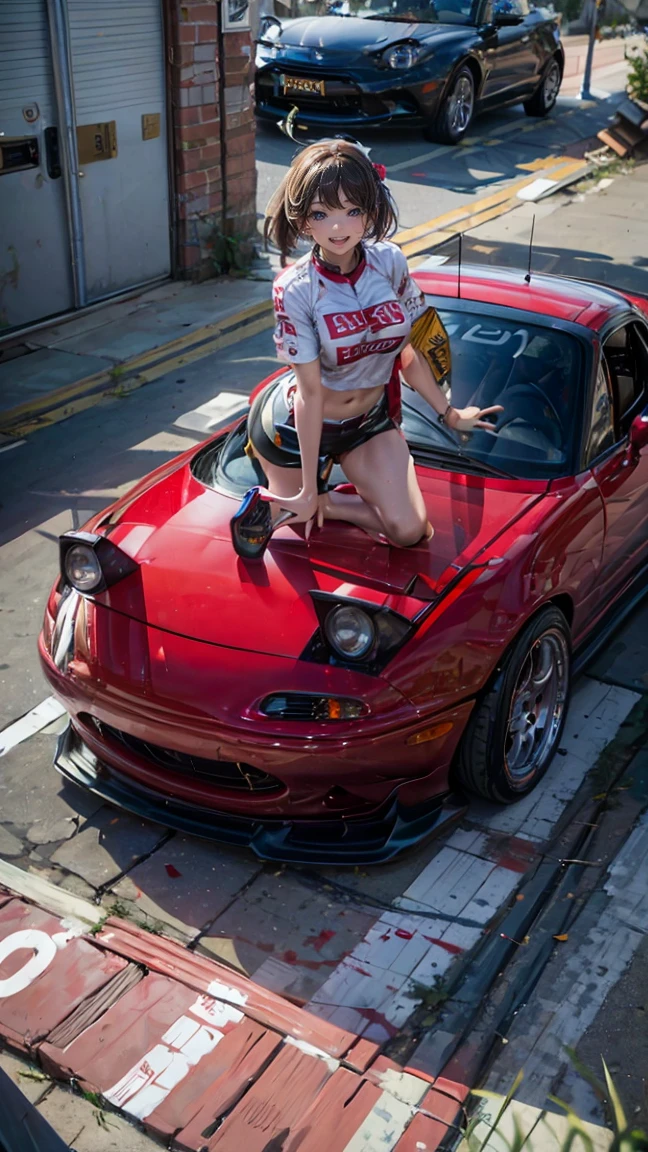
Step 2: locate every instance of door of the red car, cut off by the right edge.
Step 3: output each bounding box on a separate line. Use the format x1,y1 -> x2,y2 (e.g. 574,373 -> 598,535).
592,319 -> 648,601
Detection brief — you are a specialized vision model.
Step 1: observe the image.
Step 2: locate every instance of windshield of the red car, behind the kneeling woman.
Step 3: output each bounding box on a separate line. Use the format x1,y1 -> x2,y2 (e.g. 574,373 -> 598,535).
402,308 -> 583,479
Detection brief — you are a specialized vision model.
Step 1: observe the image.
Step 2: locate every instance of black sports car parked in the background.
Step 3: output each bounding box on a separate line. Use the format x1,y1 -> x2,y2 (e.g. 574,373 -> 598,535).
256,0 -> 565,144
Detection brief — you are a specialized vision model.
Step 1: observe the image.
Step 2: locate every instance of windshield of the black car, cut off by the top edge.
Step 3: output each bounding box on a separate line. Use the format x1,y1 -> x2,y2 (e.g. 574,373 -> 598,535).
274,0 -> 475,24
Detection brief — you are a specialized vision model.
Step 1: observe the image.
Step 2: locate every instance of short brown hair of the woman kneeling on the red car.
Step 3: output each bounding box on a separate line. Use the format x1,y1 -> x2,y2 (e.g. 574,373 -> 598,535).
263,139 -> 397,266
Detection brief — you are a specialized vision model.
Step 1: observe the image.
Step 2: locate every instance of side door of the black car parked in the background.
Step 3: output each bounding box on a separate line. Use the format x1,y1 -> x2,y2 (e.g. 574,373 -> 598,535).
482,0 -> 540,105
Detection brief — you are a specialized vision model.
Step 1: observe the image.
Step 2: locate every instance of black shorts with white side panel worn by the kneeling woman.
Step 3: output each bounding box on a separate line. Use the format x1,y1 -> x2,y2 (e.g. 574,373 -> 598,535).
248,380 -> 398,481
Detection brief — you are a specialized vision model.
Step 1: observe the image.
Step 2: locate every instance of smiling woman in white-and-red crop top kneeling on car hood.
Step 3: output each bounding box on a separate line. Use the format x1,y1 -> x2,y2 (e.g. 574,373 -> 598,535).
231,139 -> 500,547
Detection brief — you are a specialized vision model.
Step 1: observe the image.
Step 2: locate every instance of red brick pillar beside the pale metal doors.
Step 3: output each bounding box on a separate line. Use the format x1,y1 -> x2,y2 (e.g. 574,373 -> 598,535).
167,0 -> 256,279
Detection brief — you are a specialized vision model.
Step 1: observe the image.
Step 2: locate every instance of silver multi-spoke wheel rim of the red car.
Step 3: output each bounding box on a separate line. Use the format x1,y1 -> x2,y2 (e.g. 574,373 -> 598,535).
505,628 -> 570,787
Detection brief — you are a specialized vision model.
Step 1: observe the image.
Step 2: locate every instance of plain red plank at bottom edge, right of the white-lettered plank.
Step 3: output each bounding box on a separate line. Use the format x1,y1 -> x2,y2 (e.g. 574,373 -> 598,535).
202,1045 -> 331,1152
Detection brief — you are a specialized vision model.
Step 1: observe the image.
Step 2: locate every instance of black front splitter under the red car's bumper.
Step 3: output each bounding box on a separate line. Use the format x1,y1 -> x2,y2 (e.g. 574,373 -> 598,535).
54,725 -> 467,865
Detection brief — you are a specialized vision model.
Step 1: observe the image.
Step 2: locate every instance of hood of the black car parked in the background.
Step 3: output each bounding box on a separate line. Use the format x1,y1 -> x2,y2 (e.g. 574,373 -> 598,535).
259,16 -> 467,57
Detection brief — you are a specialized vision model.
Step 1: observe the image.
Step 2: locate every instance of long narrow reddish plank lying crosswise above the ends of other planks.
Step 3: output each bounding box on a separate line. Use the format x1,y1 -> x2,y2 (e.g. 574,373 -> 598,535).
96,918 -> 356,1059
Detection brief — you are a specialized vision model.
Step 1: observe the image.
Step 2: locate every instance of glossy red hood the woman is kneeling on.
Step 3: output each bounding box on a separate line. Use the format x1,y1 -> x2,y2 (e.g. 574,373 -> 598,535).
88,464 -> 544,657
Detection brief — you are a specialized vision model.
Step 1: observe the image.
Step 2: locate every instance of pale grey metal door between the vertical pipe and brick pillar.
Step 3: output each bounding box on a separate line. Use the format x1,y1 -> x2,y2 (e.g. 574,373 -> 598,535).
67,0 -> 171,300
